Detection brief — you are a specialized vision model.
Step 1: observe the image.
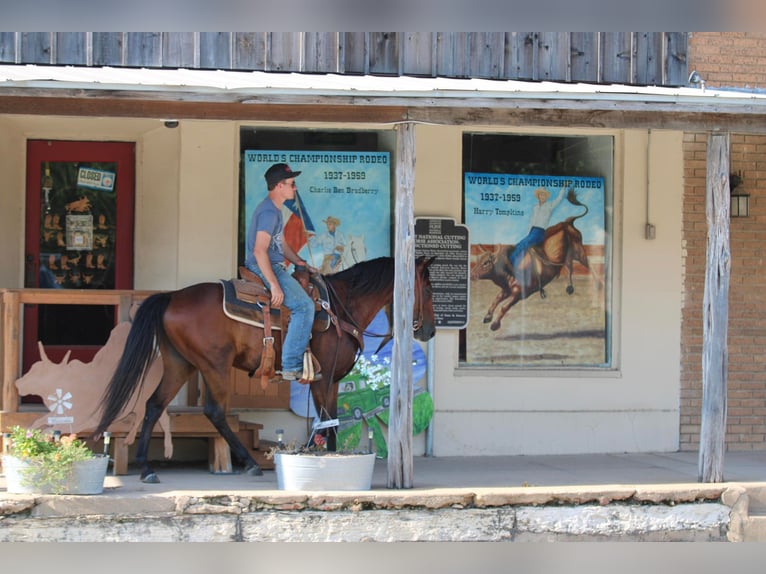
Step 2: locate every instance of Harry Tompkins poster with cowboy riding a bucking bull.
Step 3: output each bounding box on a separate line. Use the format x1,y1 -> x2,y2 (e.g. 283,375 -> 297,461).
464,173 -> 609,367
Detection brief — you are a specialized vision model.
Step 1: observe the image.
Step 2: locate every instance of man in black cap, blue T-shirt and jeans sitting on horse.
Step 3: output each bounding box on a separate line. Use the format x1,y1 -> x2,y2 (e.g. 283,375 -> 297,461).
245,163 -> 320,381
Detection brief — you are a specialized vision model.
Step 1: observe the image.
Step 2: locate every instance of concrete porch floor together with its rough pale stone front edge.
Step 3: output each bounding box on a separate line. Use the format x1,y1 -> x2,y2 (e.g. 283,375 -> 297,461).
0,452 -> 766,542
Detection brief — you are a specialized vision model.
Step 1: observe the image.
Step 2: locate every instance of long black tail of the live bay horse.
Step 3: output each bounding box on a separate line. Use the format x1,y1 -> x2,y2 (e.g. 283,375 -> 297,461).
93,293 -> 170,437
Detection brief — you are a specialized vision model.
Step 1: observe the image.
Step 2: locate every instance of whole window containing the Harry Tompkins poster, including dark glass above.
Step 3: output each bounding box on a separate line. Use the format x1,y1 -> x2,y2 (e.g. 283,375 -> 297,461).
460,133 -> 614,369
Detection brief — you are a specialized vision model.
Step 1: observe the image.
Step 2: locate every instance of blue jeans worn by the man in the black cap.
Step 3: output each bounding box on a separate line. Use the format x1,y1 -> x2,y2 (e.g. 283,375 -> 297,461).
247,265 -> 314,373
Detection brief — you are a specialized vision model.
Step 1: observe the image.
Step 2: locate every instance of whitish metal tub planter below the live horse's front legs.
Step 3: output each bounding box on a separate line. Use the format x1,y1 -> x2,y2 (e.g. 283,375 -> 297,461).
269,434 -> 375,490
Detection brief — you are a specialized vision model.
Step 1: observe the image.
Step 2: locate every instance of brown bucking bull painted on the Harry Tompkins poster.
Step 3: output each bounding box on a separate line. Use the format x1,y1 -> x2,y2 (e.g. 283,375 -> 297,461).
471,190 -> 603,331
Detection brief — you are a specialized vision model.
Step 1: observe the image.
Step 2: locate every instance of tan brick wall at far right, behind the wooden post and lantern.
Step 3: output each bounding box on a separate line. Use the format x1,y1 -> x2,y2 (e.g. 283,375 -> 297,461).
680,32 -> 766,450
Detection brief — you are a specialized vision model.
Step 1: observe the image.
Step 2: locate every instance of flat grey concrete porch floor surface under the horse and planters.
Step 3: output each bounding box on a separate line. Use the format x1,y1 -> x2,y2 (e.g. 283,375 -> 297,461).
45,452 -> 766,496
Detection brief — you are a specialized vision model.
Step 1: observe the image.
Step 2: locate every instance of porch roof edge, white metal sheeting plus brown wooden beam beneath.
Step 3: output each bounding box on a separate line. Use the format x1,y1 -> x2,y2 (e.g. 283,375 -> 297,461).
0,64 -> 766,131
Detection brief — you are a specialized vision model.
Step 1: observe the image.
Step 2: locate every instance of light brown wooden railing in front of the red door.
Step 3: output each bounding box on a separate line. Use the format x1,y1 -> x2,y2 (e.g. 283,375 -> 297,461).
0,289 -> 155,412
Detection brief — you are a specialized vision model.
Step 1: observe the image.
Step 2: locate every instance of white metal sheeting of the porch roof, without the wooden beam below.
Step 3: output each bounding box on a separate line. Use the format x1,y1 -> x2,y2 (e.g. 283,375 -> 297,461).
0,64 -> 766,108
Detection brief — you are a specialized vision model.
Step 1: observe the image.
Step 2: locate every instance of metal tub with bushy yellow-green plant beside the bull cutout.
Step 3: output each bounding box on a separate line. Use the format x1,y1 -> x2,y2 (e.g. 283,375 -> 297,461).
2,426 -> 109,494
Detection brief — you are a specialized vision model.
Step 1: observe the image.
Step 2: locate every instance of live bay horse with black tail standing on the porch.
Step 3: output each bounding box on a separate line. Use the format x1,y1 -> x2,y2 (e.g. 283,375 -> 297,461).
93,257 -> 436,483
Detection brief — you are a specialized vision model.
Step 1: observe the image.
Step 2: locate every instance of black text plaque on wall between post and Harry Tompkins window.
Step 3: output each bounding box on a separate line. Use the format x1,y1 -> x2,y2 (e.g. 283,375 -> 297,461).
415,217 -> 469,329
